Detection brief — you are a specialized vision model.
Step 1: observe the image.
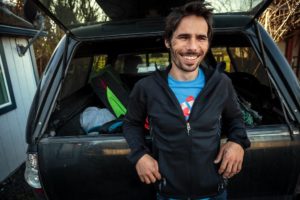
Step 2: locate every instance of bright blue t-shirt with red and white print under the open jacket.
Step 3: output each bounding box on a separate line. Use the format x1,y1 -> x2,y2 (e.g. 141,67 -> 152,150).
168,69 -> 205,120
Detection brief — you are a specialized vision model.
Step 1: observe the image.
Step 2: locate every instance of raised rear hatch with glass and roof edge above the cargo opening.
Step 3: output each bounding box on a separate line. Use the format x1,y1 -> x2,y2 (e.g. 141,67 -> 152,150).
34,0 -> 272,39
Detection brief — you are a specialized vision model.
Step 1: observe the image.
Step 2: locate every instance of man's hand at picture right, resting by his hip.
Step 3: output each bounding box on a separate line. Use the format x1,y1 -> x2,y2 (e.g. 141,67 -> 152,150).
214,141 -> 244,178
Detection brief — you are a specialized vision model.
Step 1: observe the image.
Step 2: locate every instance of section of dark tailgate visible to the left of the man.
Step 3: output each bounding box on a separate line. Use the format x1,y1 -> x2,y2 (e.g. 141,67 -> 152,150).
38,135 -> 155,200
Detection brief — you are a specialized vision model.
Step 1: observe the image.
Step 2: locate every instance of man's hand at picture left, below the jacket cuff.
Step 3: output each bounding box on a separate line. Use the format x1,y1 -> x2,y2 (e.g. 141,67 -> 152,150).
135,154 -> 161,184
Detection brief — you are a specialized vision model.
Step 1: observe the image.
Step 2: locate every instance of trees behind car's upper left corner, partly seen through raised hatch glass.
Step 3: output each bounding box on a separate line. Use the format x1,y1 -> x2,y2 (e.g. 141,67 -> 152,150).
34,0 -> 108,74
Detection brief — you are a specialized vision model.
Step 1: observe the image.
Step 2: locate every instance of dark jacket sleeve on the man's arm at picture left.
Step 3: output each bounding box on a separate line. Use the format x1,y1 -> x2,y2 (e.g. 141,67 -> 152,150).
123,81 -> 150,164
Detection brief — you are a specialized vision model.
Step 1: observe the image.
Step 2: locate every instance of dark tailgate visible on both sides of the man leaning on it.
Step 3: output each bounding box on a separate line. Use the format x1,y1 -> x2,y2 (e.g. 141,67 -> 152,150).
38,125 -> 300,199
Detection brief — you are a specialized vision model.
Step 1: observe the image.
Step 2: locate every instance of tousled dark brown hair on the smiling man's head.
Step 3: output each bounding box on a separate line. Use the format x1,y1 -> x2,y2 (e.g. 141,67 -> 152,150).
164,0 -> 213,42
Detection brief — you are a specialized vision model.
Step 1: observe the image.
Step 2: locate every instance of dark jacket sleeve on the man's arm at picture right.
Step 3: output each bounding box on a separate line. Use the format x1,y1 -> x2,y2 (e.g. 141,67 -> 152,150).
222,80 -> 250,149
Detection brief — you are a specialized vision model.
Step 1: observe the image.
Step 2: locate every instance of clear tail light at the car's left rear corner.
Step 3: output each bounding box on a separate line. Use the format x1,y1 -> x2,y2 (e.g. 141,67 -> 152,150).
24,153 -> 41,189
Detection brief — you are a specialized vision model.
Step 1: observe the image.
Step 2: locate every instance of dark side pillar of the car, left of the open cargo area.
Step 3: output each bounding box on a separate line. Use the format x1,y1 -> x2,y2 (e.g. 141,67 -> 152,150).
26,37 -> 78,144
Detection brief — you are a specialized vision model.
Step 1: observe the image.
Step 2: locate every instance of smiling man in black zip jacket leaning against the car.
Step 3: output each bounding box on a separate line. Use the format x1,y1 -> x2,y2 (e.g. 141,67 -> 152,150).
124,1 -> 250,199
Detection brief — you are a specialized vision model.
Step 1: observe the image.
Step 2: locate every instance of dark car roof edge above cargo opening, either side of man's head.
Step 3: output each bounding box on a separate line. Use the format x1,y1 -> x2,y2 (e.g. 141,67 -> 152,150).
72,15 -> 252,40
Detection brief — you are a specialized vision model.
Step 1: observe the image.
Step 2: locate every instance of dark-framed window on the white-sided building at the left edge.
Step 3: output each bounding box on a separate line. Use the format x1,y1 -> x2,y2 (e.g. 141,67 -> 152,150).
0,56 -> 16,115
